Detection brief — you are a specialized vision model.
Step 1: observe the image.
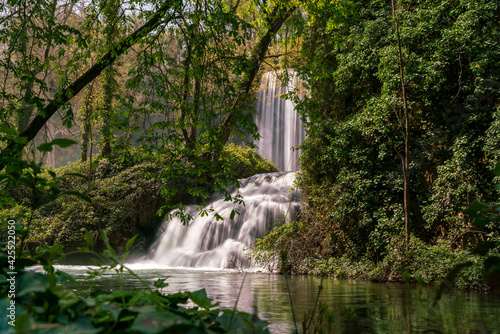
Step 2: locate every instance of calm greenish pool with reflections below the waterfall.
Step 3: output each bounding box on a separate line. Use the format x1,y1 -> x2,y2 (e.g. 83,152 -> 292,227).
42,265 -> 500,333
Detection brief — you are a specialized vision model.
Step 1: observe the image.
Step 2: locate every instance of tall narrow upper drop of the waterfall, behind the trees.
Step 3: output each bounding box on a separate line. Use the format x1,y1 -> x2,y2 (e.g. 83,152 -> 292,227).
255,72 -> 306,171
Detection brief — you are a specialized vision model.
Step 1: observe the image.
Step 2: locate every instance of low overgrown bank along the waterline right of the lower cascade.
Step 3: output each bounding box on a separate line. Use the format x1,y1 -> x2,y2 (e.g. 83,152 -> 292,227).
252,228 -> 499,291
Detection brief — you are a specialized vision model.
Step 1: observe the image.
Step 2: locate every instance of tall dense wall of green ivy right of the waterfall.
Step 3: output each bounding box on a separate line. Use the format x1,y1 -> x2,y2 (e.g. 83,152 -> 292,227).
268,0 -> 500,270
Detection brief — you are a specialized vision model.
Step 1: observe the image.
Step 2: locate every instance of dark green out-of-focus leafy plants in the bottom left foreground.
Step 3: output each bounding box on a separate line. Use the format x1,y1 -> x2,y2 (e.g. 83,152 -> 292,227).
0,234 -> 269,333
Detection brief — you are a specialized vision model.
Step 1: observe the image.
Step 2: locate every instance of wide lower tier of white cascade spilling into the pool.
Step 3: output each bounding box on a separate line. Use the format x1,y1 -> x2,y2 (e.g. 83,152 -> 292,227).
152,172 -> 300,268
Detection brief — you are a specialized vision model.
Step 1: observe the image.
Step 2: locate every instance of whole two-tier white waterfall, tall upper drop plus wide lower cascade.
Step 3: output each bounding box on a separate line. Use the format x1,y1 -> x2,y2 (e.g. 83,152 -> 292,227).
151,72 -> 305,268
